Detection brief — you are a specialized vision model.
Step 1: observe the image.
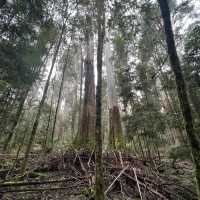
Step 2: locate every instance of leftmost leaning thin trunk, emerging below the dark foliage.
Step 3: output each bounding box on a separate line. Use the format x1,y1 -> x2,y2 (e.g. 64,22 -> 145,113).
3,89 -> 29,151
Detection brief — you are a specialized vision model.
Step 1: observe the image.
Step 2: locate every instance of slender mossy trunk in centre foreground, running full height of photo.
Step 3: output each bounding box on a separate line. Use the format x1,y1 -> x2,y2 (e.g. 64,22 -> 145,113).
95,0 -> 105,200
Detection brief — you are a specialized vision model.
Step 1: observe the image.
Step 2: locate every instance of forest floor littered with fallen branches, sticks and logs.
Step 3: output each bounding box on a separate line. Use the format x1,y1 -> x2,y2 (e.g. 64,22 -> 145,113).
0,150 -> 197,200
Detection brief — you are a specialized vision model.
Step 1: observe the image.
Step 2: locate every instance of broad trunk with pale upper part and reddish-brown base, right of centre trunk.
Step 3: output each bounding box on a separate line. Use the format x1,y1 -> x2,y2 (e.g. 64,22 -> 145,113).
105,33 -> 123,149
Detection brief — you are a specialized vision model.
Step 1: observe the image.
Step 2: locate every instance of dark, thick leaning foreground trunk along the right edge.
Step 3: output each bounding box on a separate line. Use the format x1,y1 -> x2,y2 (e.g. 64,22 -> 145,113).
158,0 -> 200,197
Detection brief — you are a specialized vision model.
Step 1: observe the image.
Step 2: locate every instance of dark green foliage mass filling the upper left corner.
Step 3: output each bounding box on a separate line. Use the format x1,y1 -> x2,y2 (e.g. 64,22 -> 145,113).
0,0 -> 55,88
